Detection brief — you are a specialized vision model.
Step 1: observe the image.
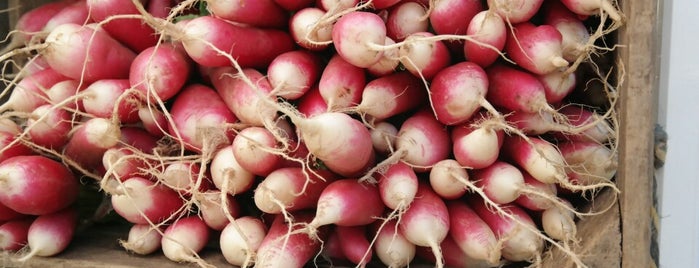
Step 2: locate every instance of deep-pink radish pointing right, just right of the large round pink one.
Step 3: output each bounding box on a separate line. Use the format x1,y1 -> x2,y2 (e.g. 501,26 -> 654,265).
485,64 -> 557,114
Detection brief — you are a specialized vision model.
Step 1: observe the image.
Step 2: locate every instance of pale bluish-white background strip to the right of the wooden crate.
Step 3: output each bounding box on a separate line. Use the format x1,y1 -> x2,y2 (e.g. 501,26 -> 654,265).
656,0 -> 699,268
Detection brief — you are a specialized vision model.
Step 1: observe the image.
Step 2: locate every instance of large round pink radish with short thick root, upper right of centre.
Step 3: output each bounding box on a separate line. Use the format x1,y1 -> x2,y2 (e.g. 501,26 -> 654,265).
429,62 -> 496,125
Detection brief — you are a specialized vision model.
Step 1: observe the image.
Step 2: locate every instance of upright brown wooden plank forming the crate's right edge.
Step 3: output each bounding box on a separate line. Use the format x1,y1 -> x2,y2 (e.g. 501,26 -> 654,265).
617,0 -> 661,268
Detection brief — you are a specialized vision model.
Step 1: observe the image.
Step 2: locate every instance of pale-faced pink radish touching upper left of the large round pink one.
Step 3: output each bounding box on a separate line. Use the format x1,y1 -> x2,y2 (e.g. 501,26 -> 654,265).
398,32 -> 451,80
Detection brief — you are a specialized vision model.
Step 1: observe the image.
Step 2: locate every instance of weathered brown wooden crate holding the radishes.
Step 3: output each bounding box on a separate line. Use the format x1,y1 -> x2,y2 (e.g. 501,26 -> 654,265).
0,0 -> 662,268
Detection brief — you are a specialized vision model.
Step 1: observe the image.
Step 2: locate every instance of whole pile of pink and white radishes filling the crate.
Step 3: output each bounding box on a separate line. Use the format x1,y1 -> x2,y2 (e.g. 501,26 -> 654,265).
0,0 -> 624,267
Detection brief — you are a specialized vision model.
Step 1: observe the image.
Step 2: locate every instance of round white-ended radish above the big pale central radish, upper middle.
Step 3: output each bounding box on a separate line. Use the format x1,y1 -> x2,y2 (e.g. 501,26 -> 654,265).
267,50 -> 322,100
